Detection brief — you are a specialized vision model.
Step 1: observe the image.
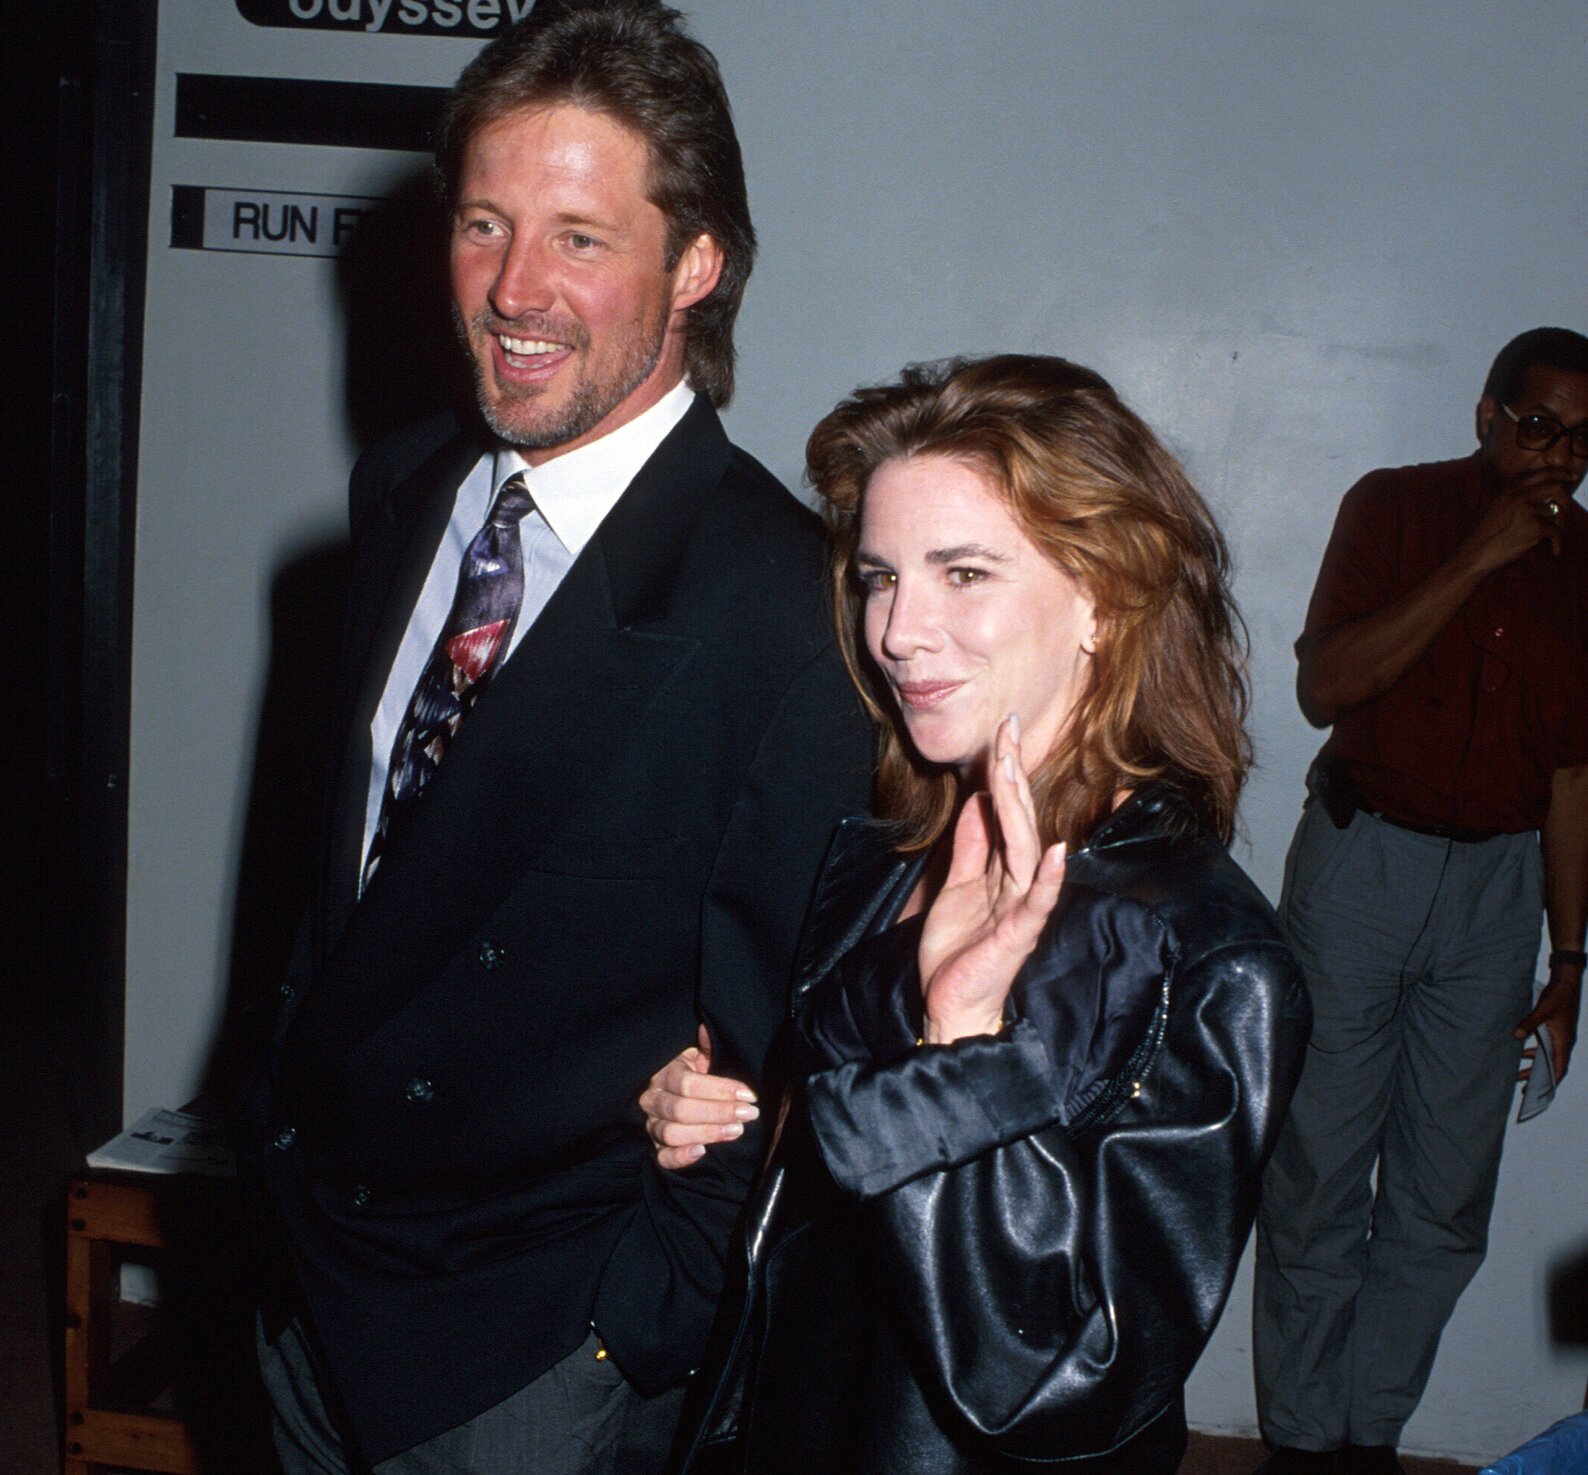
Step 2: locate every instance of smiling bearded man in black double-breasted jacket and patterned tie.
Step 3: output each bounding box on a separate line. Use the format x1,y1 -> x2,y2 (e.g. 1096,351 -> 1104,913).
248,0 -> 870,1475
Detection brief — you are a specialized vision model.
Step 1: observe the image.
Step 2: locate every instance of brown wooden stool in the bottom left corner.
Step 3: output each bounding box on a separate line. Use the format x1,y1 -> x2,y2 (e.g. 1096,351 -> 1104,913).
65,1175 -> 204,1475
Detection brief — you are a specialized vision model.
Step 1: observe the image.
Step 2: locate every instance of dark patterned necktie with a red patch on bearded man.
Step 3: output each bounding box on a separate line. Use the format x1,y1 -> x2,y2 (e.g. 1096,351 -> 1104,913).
359,472 -> 535,895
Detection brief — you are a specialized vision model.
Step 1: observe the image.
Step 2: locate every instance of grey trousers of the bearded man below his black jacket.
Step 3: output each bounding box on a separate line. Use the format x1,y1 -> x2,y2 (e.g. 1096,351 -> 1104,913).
259,1321 -> 683,1475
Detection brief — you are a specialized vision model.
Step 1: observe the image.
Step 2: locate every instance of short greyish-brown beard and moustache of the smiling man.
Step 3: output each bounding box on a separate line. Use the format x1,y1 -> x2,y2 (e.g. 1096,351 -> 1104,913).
453,303 -> 667,451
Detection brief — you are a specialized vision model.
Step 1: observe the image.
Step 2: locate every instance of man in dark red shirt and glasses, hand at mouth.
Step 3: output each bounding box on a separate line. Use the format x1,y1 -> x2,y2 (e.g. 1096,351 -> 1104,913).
1253,329 -> 1588,1475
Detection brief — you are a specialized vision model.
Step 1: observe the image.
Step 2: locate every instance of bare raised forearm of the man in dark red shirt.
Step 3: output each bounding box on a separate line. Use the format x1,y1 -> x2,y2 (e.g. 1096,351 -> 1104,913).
1296,479 -> 1553,727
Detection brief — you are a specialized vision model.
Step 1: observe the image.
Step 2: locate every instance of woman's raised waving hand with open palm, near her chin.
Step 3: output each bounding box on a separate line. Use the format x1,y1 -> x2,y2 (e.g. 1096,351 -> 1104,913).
918,718 -> 1064,1045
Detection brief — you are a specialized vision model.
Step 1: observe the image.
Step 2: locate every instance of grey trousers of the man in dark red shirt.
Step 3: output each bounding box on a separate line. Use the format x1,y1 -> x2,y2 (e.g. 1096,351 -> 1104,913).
1253,803 -> 1544,1450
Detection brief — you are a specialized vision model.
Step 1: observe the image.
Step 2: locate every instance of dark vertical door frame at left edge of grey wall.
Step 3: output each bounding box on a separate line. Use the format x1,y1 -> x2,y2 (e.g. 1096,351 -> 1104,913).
44,0 -> 157,1150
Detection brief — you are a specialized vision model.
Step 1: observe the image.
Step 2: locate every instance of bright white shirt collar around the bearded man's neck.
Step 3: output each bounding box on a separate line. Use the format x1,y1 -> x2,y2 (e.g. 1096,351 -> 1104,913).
491,381 -> 694,557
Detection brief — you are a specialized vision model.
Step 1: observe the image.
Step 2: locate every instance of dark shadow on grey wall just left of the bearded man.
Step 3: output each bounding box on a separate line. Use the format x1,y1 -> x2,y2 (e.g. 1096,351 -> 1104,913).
205,168 -> 473,1100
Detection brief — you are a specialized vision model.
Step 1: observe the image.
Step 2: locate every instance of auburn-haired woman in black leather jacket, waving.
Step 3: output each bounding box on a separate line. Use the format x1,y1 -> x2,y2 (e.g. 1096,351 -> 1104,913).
640,356 -> 1309,1475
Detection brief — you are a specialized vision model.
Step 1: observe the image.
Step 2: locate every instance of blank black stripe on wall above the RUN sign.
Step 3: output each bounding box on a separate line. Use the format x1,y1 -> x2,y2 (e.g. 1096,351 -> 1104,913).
176,71 -> 448,154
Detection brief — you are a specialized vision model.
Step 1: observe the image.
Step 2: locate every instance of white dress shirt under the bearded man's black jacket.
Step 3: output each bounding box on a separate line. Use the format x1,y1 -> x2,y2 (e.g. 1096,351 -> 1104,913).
368,383 -> 694,867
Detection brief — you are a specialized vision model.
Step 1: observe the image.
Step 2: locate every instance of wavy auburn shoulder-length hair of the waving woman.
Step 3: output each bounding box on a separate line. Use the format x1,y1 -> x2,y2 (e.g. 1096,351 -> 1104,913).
805,354 -> 1251,849
